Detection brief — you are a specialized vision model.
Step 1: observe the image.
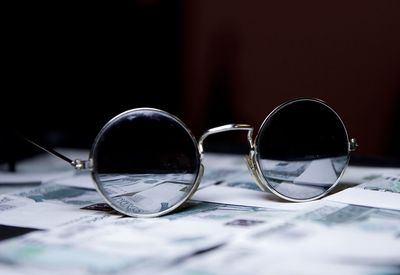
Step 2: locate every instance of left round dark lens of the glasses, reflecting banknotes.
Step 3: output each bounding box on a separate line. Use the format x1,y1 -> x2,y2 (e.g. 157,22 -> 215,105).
90,108 -> 200,217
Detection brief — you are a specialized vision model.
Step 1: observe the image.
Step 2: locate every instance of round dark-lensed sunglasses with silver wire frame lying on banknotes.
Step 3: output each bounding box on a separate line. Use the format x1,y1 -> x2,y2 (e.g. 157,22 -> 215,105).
28,98 -> 357,217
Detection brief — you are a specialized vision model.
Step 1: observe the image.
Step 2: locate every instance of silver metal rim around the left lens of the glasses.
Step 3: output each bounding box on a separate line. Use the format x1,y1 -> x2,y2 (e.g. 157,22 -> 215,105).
89,108 -> 204,218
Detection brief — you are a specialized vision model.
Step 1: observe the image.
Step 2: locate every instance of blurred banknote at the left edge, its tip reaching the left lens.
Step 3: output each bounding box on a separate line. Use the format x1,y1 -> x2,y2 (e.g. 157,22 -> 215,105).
0,183 -> 120,229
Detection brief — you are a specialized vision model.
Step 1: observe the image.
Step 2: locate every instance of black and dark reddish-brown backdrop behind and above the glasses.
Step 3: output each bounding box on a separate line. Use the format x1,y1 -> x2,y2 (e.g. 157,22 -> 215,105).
0,0 -> 400,166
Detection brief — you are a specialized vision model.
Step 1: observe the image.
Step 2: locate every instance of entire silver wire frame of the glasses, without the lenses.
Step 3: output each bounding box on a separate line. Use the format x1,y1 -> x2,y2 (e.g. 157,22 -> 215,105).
26,98 -> 358,218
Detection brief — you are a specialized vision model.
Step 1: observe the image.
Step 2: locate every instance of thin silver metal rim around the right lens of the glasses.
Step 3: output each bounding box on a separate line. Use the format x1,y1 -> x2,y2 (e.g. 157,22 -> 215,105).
250,98 -> 350,202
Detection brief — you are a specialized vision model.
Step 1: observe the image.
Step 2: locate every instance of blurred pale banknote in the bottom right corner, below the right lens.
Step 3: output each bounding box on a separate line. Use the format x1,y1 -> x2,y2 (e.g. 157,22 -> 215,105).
228,201 -> 400,274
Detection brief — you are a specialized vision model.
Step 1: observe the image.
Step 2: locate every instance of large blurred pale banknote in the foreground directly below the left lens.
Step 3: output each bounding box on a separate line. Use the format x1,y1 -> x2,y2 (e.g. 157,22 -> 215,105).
0,201 -> 289,274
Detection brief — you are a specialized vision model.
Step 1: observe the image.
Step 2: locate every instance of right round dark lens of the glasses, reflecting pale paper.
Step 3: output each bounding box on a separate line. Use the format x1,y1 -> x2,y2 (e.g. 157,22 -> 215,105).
255,99 -> 349,201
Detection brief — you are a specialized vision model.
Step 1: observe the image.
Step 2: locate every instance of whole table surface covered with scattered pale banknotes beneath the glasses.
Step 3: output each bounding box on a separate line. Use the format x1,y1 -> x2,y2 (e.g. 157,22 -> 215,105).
0,149 -> 400,274
